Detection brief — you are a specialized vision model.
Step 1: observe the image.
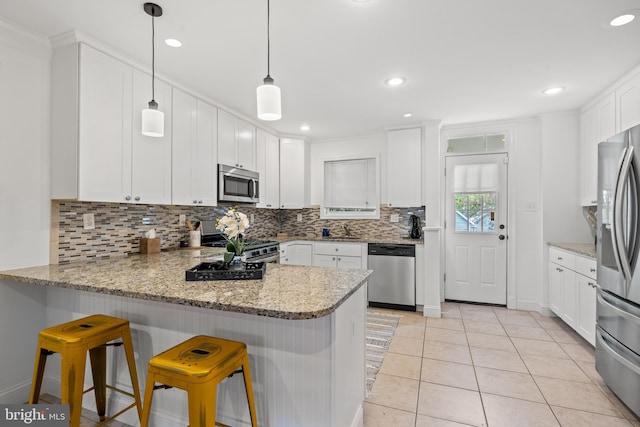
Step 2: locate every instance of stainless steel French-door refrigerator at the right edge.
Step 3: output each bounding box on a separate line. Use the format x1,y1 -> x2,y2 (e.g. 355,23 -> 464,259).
596,126 -> 640,415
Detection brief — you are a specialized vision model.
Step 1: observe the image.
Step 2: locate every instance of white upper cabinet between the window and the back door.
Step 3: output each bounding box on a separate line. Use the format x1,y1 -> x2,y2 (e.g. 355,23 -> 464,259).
387,128 -> 422,207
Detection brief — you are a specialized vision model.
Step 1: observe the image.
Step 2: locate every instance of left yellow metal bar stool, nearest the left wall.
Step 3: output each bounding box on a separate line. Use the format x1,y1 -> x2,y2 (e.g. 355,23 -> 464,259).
29,314 -> 142,427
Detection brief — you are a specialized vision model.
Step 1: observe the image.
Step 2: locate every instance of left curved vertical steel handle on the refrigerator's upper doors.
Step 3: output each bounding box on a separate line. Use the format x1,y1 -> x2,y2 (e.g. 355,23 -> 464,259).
613,146 -> 633,283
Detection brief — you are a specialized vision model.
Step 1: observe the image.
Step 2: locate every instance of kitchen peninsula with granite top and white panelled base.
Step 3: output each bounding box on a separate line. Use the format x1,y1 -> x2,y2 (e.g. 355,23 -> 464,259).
0,250 -> 370,426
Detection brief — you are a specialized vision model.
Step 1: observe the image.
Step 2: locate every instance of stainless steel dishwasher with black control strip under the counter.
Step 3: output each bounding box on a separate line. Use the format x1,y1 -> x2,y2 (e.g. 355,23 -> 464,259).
367,243 -> 416,311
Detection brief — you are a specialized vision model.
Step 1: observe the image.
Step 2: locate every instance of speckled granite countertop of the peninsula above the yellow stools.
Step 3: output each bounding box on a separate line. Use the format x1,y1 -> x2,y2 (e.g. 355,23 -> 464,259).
0,248 -> 372,320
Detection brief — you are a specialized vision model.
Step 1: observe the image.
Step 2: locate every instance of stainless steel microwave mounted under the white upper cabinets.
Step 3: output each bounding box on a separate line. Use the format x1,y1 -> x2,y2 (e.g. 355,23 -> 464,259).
218,165 -> 260,203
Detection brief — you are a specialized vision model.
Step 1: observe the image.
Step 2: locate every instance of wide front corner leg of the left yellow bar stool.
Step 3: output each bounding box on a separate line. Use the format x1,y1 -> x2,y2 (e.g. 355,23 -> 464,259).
60,351 -> 87,427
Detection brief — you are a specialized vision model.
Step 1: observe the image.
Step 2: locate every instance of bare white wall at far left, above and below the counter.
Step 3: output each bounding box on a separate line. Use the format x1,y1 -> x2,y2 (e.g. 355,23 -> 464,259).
0,21 -> 50,403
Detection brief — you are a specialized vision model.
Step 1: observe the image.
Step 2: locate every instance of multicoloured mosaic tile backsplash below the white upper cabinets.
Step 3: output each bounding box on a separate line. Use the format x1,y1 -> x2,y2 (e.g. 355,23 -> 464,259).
52,201 -> 424,264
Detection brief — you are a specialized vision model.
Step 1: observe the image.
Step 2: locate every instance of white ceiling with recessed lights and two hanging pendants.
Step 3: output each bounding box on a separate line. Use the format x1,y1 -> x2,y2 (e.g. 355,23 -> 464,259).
0,0 -> 640,139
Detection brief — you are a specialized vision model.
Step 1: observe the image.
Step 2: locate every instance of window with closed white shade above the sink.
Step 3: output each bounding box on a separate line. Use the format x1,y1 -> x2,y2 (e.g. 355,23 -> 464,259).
320,156 -> 380,219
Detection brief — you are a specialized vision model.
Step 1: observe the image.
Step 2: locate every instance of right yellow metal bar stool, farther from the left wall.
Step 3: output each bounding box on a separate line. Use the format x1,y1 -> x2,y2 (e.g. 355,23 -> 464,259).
140,335 -> 258,427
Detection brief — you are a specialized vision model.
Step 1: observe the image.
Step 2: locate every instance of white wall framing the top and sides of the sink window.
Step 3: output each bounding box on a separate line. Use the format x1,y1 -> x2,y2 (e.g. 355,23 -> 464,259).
310,133 -> 387,206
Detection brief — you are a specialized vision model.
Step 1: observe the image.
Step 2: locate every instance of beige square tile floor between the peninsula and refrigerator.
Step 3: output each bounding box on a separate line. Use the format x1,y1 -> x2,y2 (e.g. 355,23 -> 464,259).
364,303 -> 640,427
